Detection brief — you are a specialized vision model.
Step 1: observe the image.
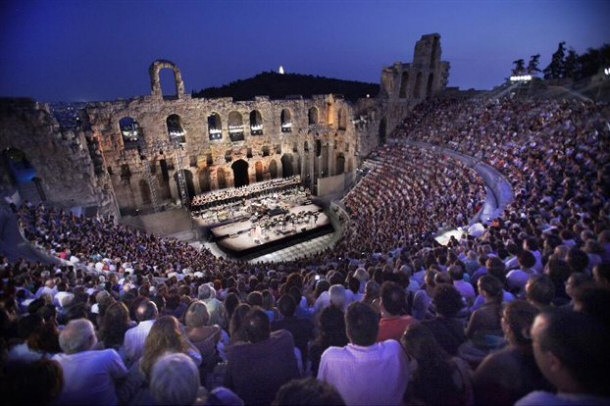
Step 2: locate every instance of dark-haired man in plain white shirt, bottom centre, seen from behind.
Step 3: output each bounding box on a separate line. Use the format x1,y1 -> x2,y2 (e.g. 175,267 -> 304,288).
318,302 -> 409,405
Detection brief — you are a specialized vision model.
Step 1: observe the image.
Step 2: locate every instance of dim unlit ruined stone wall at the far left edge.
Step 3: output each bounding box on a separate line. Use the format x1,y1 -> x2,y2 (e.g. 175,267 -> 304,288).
0,99 -> 116,214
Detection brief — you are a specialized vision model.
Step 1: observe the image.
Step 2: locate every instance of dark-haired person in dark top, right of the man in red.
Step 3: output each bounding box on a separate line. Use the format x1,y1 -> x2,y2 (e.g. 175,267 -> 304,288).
422,285 -> 466,356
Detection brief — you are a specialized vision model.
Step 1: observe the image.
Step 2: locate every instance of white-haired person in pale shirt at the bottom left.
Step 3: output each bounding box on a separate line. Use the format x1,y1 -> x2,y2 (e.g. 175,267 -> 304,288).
52,319 -> 127,405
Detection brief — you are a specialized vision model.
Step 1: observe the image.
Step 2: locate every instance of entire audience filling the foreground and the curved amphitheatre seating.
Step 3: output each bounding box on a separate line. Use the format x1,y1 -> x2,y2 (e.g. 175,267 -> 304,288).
0,93 -> 610,405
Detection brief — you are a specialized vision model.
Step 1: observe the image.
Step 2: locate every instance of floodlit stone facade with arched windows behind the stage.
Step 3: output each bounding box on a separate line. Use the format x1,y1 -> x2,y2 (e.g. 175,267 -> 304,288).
86,65 -> 358,209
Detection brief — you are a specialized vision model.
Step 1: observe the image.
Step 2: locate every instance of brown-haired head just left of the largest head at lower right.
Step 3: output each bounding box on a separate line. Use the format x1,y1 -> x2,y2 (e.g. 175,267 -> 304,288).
502,300 -> 538,345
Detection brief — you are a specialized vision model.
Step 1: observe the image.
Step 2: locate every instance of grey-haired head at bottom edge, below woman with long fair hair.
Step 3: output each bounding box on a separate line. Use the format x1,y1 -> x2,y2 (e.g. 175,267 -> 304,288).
150,353 -> 200,405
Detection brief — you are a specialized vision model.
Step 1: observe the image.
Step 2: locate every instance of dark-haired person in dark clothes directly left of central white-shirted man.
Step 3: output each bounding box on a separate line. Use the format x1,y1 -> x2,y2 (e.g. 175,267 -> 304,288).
309,302 -> 346,375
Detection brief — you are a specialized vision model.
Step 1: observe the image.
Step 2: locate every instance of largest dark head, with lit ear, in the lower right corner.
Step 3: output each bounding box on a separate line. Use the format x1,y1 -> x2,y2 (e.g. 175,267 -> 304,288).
531,309 -> 610,397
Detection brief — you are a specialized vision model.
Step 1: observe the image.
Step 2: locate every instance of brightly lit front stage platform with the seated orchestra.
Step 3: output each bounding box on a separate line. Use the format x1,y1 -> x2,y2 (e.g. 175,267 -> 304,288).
210,204 -> 334,259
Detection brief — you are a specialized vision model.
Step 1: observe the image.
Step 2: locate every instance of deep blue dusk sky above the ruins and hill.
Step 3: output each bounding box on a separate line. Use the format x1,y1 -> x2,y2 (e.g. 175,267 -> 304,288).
0,0 -> 610,101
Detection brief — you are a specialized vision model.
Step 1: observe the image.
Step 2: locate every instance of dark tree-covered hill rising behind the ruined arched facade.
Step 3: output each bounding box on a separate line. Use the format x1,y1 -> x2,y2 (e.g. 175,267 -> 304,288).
193,72 -> 379,101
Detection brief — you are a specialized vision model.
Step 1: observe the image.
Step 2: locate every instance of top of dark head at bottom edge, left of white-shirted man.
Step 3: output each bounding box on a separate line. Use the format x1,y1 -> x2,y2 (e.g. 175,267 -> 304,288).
271,377 -> 345,406
